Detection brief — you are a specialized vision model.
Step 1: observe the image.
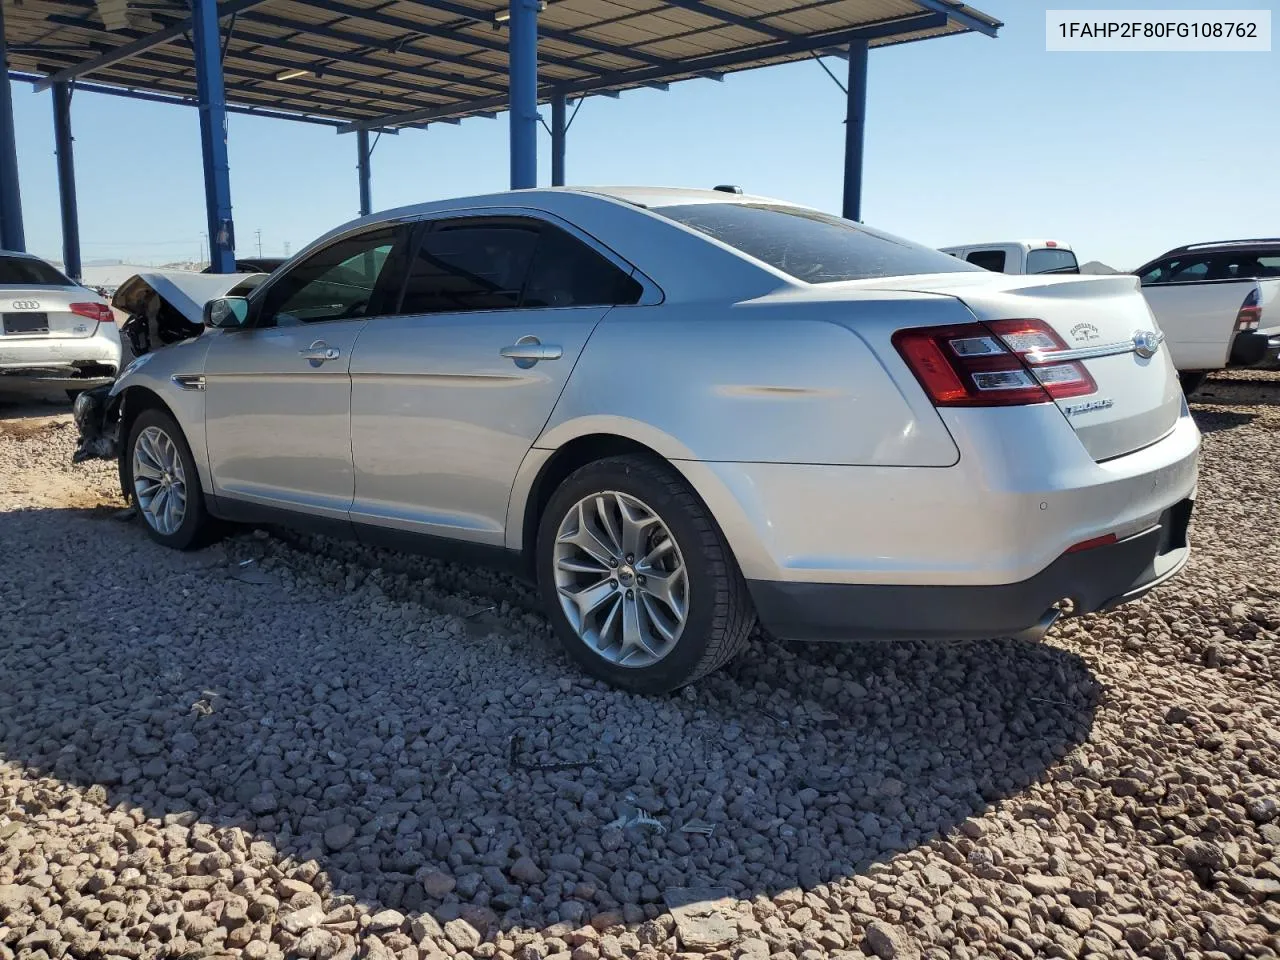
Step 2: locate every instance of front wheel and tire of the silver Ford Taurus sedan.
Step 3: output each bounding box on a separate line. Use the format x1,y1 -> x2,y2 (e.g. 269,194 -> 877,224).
125,410 -> 210,550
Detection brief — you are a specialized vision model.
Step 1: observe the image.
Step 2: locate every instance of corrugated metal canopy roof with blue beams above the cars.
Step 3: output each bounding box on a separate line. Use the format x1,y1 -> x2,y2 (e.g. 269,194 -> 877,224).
0,0 -> 1001,132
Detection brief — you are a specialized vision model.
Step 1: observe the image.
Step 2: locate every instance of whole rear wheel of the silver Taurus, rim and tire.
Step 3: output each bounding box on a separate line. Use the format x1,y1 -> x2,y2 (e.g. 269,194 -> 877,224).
538,457 -> 755,692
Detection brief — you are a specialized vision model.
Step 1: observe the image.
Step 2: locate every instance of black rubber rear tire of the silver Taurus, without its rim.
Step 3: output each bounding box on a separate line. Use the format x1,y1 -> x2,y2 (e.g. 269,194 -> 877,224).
535,456 -> 755,694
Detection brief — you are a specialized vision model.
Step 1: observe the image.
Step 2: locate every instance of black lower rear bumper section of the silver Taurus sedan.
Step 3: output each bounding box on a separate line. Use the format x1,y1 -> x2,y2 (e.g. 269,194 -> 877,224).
748,498 -> 1194,641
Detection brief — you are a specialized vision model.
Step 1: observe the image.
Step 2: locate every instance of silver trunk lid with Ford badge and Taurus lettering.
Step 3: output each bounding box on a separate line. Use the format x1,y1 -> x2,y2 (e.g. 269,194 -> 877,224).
849,273 -> 1183,461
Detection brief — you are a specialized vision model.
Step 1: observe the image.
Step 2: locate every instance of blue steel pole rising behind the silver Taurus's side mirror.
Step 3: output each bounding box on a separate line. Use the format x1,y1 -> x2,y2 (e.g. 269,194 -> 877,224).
191,0 -> 236,274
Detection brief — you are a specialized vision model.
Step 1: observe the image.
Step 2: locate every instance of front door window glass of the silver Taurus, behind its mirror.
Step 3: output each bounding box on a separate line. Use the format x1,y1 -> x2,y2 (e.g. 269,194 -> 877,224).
257,227 -> 404,326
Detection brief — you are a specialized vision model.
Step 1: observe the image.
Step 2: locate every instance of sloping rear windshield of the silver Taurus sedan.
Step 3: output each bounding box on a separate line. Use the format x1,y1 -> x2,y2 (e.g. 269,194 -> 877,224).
654,204 -> 978,283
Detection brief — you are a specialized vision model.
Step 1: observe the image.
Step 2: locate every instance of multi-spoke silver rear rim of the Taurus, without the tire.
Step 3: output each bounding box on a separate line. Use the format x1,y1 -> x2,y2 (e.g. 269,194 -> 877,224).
556,490 -> 689,667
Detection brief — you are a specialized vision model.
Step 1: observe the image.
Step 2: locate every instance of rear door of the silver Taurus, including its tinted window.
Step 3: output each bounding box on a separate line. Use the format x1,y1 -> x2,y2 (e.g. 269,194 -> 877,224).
351,216 -> 641,545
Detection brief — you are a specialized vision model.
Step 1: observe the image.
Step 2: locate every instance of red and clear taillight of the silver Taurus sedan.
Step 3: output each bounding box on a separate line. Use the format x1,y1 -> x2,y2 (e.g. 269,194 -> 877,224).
893,320 -> 1098,407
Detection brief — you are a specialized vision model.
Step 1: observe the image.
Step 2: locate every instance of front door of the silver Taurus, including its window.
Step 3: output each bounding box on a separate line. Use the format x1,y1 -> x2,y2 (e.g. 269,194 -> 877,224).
205,224 -> 411,522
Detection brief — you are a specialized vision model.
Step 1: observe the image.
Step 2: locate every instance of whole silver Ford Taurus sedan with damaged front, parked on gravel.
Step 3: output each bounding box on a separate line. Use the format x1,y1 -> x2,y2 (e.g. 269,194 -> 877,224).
78,188 -> 1199,691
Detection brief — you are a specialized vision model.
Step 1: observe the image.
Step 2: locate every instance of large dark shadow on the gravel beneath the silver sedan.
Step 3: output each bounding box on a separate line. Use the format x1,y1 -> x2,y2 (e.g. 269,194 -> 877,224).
0,511 -> 1100,933
